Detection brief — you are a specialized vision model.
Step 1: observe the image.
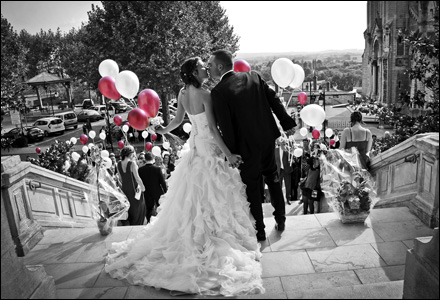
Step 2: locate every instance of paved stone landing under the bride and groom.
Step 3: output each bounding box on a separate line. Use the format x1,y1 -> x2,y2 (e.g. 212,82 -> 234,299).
20,204 -> 433,299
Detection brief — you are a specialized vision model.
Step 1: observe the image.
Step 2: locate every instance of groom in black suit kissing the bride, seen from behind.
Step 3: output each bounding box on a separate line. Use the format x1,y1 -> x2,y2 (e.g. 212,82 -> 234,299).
207,50 -> 296,241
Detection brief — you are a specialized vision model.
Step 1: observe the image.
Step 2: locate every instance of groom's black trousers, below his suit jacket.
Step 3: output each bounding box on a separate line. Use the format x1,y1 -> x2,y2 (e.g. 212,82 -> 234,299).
240,141 -> 286,232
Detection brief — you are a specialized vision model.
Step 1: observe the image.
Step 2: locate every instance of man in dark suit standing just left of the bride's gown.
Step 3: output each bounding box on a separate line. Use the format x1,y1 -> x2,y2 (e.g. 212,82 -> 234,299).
139,152 -> 167,223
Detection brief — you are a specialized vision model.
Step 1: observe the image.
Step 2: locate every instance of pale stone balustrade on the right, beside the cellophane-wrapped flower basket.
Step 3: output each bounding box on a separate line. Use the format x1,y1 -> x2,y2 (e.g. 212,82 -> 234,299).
371,132 -> 439,228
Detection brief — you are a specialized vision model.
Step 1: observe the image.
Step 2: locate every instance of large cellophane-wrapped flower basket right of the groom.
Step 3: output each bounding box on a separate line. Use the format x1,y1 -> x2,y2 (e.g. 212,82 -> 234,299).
320,148 -> 378,223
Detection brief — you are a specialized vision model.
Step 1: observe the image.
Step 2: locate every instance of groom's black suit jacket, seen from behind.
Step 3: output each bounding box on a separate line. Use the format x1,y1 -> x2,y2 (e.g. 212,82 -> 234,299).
211,71 -> 296,156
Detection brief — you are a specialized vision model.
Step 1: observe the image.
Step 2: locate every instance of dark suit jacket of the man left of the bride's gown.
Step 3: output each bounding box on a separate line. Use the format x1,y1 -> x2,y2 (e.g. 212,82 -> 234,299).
138,164 -> 167,199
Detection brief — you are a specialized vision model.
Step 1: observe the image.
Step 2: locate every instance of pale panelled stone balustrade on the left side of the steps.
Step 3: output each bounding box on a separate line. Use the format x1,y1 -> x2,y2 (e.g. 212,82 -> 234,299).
1,156 -> 111,256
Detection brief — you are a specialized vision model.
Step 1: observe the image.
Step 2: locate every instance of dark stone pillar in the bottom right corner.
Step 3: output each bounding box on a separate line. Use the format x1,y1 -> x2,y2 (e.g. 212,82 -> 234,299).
403,227 -> 439,299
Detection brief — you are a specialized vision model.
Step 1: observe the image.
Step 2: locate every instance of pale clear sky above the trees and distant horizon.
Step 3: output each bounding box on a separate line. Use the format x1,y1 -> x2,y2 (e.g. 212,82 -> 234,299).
1,1 -> 367,53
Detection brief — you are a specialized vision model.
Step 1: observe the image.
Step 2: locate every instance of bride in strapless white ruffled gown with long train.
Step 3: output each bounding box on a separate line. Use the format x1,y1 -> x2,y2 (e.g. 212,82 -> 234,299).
105,57 -> 265,296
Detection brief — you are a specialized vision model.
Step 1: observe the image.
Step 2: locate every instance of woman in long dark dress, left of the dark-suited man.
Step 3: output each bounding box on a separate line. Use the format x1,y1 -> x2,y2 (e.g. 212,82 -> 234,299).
118,146 -> 146,226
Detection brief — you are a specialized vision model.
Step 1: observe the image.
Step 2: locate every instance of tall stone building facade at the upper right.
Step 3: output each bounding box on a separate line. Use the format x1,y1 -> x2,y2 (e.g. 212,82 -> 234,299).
362,1 -> 438,105
